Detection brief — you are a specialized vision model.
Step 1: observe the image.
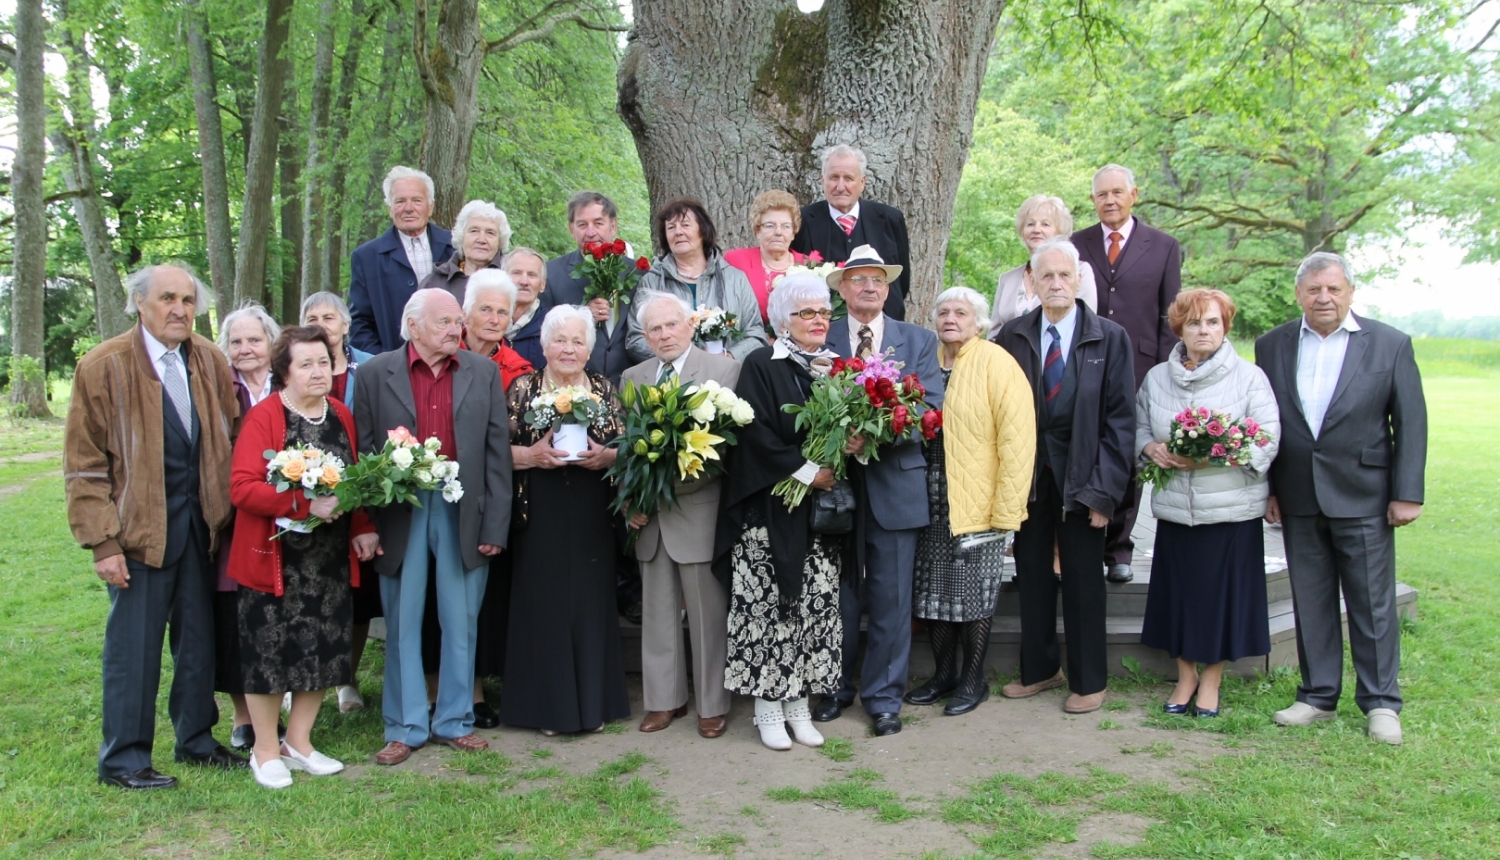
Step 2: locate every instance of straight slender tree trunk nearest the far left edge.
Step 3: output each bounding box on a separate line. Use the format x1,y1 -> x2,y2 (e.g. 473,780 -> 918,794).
11,0 -> 53,417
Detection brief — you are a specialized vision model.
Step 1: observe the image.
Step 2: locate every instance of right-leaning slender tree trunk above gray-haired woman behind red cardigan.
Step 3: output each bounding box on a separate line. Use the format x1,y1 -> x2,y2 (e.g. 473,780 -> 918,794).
234,0 -> 293,312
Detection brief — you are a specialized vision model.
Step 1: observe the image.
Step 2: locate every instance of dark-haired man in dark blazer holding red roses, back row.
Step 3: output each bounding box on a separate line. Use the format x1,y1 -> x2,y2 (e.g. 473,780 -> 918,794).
539,191 -> 635,386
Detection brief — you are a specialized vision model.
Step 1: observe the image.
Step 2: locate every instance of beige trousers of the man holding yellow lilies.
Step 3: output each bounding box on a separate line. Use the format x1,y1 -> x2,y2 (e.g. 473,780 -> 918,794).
641,542 -> 729,717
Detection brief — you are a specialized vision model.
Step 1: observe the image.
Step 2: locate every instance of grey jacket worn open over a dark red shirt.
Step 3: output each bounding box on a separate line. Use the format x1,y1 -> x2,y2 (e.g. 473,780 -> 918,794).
354,348 -> 512,576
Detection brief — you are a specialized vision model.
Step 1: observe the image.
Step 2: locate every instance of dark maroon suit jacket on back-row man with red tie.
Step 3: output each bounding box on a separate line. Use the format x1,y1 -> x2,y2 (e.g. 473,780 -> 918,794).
1073,216 -> 1182,390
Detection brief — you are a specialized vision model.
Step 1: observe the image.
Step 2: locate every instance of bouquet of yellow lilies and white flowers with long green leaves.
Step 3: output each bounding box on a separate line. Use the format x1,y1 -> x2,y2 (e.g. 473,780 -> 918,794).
608,377 -> 755,542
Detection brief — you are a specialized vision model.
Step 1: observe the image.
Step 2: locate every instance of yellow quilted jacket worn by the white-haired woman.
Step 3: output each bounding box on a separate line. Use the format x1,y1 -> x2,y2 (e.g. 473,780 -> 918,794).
942,338 -> 1037,536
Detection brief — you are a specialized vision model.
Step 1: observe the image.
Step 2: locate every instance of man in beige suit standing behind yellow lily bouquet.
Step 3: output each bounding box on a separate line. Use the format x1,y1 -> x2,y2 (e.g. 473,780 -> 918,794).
621,291 -> 740,737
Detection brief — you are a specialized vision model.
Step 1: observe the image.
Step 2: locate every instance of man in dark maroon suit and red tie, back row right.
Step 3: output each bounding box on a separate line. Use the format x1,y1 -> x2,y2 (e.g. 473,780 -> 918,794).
1073,164 -> 1182,582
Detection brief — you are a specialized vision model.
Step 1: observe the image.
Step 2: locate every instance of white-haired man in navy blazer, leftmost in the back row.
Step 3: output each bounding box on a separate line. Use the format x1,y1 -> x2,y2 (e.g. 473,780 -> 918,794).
350,167 -> 453,354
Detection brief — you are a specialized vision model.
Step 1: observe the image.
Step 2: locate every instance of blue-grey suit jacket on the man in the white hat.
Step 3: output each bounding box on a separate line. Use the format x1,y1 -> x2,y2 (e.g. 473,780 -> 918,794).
827,317 -> 944,531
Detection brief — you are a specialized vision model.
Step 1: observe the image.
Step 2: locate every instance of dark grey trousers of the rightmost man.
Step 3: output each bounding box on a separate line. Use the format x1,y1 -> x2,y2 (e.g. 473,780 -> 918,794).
1281,515 -> 1401,713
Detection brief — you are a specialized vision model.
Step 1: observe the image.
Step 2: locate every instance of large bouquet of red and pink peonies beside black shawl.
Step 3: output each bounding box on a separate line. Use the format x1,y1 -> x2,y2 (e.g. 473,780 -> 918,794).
771,350 -> 942,509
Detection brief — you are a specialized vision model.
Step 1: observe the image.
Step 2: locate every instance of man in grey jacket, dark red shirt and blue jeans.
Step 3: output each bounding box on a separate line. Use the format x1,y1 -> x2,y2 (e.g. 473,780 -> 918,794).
354,290 -> 512,765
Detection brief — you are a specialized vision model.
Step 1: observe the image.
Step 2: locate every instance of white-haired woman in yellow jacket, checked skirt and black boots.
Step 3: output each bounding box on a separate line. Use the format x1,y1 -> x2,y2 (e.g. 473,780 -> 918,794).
906,287 -> 1037,716
